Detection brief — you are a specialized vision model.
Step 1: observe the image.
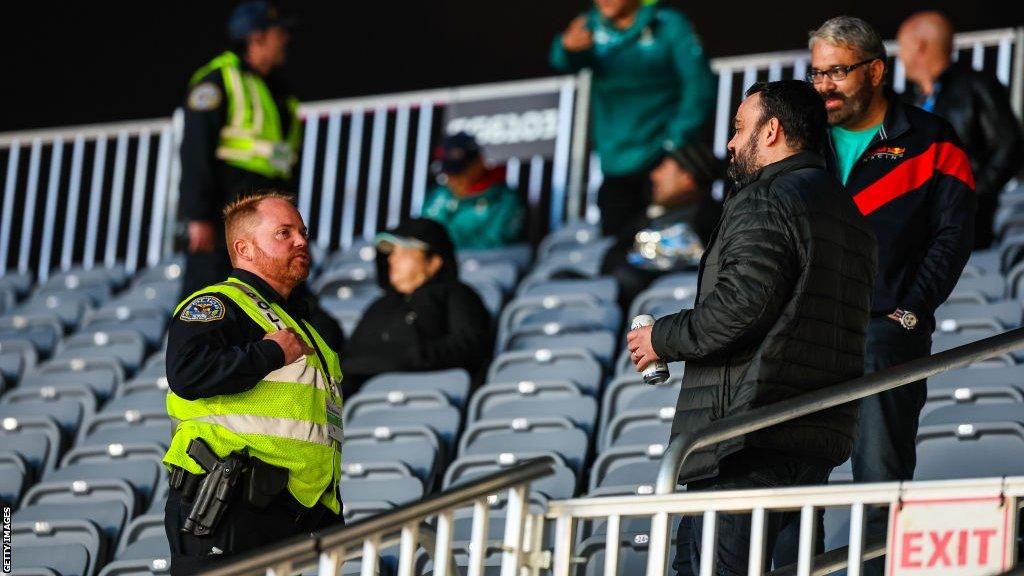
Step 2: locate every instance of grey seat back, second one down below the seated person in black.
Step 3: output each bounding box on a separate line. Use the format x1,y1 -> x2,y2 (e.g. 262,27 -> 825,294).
344,390 -> 462,448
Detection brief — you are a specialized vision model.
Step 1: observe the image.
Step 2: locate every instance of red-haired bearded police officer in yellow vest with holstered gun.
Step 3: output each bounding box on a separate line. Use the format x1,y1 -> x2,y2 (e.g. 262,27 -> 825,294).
164,191 -> 343,574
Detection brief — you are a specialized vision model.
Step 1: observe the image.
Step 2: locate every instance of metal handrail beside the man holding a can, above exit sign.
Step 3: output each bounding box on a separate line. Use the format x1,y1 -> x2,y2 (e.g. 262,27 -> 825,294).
654,328 -> 1024,494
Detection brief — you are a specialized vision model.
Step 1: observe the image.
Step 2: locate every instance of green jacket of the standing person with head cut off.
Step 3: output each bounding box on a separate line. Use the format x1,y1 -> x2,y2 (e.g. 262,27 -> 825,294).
551,4 -> 715,176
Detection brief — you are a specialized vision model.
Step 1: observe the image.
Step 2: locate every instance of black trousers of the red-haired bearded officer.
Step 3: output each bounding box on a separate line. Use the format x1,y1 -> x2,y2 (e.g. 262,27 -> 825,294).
164,483 -> 345,576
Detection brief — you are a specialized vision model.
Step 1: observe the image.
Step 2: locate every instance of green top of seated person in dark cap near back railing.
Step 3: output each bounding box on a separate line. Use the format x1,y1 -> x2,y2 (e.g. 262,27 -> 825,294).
423,177 -> 523,250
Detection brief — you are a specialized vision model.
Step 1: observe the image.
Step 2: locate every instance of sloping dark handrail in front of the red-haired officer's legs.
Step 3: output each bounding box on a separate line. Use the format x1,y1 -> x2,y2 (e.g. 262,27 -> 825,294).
198,459 -> 554,576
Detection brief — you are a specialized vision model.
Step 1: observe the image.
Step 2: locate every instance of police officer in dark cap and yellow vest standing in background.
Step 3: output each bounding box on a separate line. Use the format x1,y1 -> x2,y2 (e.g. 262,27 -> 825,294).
180,0 -> 300,295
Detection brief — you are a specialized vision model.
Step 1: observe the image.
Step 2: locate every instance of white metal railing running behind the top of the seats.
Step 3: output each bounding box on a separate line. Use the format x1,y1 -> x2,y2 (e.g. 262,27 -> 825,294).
0,28 -> 1024,280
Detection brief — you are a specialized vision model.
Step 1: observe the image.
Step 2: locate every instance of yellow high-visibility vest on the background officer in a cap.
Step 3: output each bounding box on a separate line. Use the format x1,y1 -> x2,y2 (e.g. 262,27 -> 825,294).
193,52 -> 300,178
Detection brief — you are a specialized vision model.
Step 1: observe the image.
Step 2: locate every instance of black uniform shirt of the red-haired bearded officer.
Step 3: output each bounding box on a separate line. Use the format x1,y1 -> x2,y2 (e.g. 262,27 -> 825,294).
167,269 -> 343,400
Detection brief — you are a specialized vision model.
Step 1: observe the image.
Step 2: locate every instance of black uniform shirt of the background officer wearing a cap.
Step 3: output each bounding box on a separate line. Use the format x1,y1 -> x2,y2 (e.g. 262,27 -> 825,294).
180,52 -> 292,221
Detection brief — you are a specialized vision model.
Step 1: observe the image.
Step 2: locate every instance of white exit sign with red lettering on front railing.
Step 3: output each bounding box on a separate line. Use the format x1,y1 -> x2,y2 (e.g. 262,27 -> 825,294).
887,496 -> 1015,576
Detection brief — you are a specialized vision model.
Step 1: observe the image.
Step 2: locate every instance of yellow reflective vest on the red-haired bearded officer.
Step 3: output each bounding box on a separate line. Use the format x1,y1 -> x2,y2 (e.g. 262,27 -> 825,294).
164,278 -> 342,512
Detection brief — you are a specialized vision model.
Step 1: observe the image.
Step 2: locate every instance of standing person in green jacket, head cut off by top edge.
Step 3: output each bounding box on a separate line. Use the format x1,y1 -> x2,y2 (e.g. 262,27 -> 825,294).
551,0 -> 715,235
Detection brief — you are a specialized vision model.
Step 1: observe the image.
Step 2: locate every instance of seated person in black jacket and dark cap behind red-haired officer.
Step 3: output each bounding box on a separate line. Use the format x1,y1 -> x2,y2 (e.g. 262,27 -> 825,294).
341,218 -> 494,395
